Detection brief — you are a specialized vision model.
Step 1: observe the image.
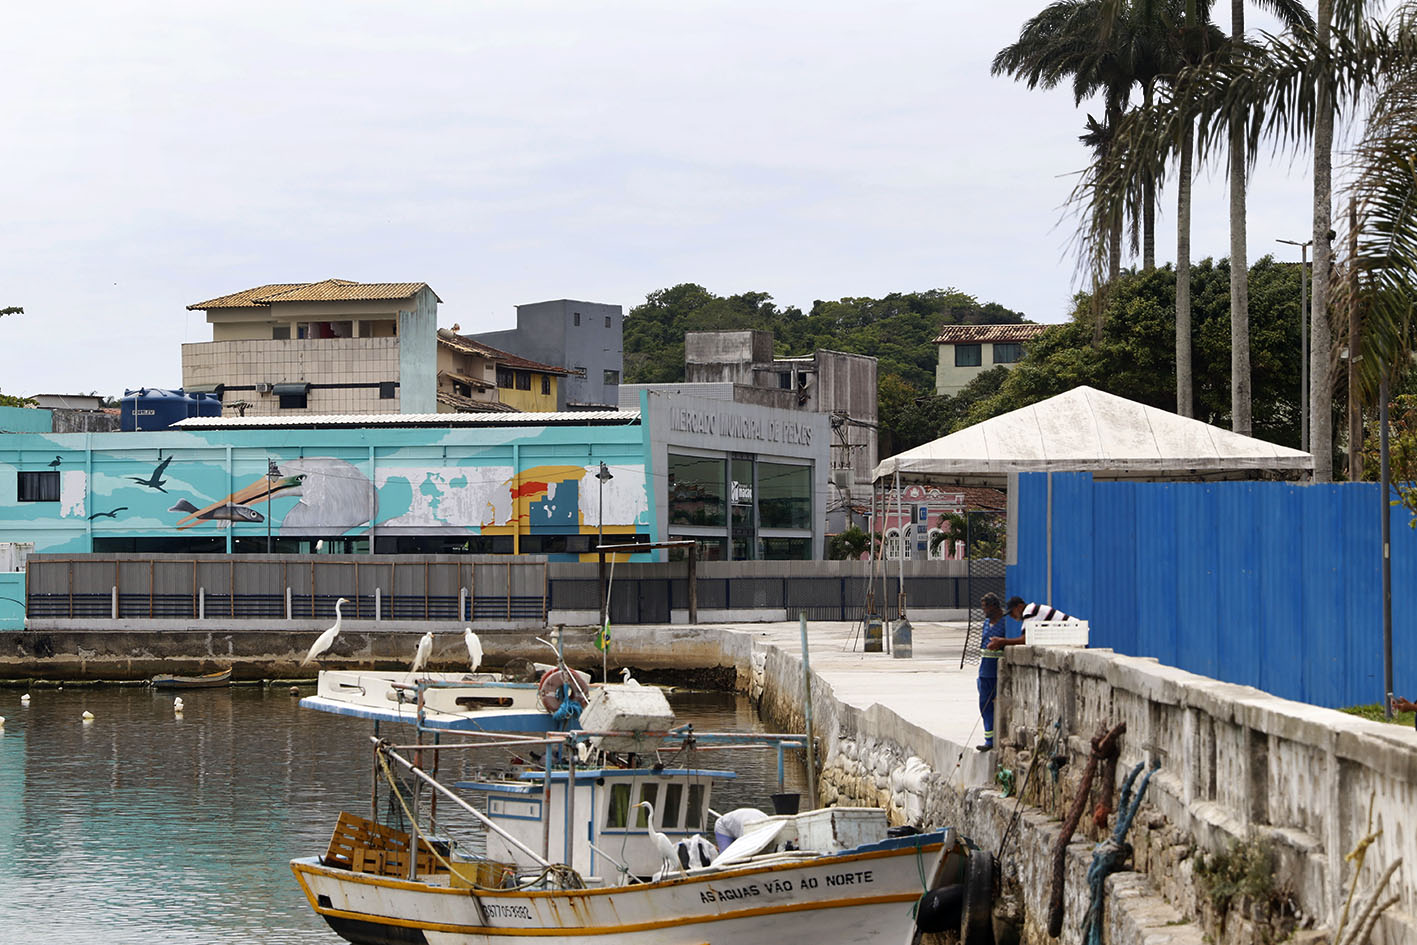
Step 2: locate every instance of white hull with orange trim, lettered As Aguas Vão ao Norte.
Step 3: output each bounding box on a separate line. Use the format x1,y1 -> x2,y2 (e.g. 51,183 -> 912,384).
290,833 -> 944,945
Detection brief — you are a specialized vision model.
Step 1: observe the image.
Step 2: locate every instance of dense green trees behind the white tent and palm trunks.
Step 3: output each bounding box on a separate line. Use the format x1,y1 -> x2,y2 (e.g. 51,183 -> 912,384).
965,256 -> 1299,446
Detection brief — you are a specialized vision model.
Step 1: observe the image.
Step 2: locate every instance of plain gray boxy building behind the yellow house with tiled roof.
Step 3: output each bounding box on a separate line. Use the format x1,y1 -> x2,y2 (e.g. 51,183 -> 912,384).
468,299 -> 625,411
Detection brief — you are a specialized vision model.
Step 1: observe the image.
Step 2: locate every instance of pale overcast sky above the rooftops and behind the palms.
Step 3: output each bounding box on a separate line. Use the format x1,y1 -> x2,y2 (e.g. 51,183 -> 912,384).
0,0 -> 1312,395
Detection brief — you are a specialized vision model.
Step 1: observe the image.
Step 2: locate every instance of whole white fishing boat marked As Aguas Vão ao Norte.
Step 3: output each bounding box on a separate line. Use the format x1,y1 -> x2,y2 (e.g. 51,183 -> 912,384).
290,687 -> 993,945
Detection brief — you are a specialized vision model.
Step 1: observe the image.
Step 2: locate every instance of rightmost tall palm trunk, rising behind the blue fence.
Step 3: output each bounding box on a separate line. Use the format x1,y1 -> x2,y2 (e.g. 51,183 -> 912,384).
1309,0 -> 1333,482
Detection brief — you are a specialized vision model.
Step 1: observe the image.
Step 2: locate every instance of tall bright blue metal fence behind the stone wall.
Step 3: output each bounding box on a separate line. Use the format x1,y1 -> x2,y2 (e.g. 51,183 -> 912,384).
1007,473 -> 1417,707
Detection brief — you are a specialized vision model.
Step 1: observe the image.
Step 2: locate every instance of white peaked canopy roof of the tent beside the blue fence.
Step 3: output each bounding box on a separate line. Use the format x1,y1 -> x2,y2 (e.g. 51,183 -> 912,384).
876,387 -> 1314,485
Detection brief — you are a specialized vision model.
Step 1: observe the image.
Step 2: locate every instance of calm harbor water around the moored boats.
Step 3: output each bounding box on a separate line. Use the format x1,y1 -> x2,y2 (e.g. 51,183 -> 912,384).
0,687 -> 802,945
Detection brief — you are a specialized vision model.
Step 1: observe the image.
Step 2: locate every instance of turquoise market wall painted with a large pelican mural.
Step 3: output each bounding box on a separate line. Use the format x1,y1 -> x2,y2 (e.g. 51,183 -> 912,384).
0,424 -> 660,553
